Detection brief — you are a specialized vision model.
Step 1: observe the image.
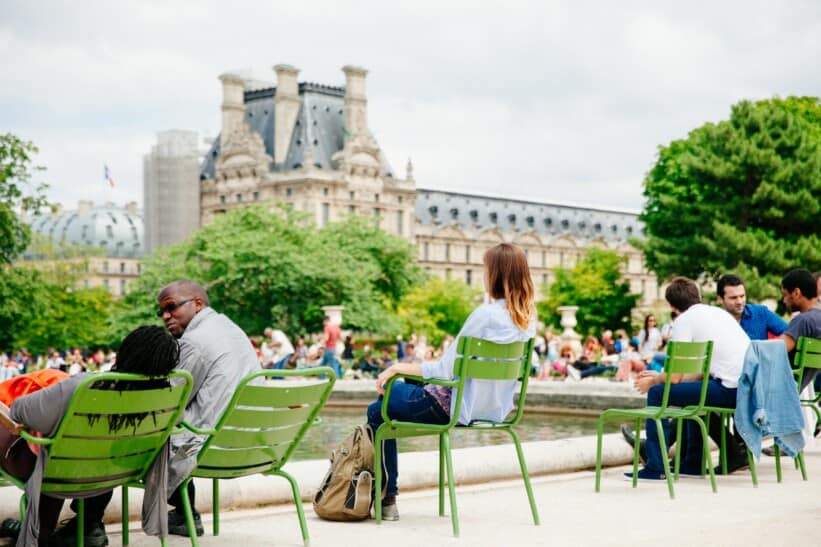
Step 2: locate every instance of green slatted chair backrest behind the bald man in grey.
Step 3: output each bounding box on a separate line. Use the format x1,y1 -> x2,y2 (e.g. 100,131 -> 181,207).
193,367 -> 336,478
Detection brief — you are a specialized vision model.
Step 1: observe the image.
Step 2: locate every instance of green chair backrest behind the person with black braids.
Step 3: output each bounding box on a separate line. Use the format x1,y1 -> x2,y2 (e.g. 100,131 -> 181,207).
42,371 -> 193,493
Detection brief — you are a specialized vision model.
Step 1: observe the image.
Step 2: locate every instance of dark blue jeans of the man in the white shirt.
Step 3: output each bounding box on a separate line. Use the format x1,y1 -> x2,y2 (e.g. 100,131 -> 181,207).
645,378 -> 736,473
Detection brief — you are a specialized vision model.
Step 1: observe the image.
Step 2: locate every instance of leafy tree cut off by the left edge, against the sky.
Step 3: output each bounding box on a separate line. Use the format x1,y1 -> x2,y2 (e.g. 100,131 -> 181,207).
0,133 -> 46,264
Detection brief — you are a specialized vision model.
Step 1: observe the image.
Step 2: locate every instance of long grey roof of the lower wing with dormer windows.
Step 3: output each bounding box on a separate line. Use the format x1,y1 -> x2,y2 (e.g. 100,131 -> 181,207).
416,188 -> 644,241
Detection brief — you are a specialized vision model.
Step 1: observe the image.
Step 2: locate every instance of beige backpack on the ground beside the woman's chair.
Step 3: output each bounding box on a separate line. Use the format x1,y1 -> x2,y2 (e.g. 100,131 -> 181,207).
314,424 -> 387,521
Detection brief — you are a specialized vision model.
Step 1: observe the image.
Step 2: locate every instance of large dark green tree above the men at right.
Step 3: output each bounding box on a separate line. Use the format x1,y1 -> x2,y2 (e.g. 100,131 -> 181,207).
634,97 -> 821,298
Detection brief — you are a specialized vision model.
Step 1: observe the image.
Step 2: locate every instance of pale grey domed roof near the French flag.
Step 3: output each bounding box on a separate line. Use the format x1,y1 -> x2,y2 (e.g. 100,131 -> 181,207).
31,201 -> 144,258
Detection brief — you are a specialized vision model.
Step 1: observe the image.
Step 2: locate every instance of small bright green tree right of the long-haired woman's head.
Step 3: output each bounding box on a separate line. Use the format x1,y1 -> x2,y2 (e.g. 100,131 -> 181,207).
536,247 -> 638,334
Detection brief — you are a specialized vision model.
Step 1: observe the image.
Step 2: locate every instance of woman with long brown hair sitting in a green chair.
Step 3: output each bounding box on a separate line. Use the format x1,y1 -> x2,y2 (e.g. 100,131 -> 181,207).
368,243 -> 536,520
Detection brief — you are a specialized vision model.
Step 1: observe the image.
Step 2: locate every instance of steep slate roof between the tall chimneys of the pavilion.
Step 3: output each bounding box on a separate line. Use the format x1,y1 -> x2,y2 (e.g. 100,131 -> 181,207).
200,82 -> 393,179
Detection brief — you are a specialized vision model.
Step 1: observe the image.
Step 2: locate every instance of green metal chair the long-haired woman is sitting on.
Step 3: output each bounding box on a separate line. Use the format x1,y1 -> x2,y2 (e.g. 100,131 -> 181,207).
374,336 -> 539,536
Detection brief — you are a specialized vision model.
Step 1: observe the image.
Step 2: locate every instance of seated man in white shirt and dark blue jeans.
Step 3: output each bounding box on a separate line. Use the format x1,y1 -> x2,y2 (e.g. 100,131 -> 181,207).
626,277 -> 750,480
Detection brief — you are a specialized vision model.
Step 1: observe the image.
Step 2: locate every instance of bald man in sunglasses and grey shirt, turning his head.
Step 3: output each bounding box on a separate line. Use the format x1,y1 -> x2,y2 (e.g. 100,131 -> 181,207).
157,280 -> 260,536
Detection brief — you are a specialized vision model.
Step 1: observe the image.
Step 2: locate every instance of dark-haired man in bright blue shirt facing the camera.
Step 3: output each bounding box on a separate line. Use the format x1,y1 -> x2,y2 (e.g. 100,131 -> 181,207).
716,274 -> 787,340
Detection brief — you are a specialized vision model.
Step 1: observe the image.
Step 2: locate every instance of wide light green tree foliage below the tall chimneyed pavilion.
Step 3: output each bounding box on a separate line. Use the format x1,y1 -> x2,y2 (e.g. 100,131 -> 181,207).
111,207 -> 421,342
